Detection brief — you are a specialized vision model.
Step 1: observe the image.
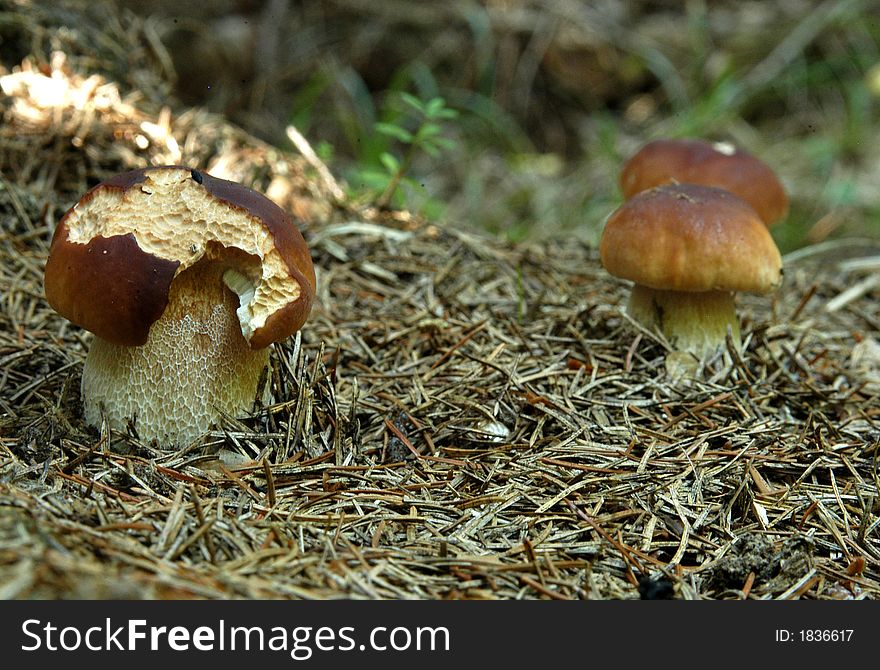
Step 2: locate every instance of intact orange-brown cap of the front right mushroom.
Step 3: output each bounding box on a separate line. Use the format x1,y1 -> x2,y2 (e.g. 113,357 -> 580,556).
599,184 -> 782,293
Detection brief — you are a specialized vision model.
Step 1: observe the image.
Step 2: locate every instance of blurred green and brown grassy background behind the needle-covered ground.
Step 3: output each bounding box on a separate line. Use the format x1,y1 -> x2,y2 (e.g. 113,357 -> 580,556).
0,0 -> 880,251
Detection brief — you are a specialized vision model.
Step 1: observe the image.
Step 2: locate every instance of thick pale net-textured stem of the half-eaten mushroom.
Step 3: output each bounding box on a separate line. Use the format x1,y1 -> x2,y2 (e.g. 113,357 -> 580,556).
82,263 -> 269,447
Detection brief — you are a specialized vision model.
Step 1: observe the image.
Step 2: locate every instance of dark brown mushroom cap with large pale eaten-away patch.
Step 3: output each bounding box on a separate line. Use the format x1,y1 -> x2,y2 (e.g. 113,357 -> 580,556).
44,165 -> 315,349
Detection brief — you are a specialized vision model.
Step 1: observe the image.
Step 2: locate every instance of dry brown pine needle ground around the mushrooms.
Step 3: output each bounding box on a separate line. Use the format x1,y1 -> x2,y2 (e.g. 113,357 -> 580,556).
0,6 -> 880,599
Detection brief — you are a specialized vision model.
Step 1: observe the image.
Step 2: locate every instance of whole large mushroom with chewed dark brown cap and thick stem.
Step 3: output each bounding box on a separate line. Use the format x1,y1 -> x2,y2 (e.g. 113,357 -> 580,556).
45,166 -> 315,445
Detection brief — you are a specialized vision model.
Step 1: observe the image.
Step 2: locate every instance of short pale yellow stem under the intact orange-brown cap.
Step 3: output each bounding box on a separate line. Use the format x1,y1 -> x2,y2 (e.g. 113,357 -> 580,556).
627,284 -> 740,357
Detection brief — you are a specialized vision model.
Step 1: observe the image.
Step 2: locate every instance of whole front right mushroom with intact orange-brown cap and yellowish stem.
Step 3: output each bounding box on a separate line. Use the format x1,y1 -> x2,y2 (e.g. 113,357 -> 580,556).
599,184 -> 782,357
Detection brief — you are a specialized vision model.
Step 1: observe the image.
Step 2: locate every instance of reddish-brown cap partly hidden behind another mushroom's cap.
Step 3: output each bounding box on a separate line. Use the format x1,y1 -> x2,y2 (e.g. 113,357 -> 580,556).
620,139 -> 788,226
